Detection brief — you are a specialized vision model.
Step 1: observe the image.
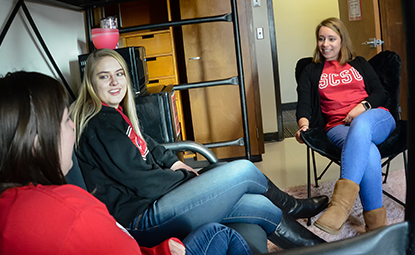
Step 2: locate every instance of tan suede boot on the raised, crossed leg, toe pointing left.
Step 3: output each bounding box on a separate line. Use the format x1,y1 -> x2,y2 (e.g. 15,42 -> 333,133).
314,179 -> 359,235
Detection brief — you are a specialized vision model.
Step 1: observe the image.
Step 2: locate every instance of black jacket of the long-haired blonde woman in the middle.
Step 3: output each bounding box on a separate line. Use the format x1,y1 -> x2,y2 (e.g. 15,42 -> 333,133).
76,106 -> 195,227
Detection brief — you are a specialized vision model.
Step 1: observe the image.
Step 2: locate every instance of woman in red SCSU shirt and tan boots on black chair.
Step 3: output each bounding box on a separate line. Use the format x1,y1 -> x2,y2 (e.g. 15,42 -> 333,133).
296,18 -> 395,234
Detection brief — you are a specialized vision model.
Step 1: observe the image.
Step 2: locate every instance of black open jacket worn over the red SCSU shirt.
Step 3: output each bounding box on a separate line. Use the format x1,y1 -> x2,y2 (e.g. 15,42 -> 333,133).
296,57 -> 386,129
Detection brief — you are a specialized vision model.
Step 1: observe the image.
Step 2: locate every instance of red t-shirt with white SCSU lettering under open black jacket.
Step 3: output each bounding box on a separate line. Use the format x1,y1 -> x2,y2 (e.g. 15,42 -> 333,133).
319,60 -> 368,131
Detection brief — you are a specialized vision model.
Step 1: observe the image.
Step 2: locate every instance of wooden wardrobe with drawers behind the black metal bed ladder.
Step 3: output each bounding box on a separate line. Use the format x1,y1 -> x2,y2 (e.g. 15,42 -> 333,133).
101,0 -> 264,158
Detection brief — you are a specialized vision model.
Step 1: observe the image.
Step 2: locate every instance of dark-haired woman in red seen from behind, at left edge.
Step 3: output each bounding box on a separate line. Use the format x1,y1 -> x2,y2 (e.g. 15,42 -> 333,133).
0,72 -> 252,255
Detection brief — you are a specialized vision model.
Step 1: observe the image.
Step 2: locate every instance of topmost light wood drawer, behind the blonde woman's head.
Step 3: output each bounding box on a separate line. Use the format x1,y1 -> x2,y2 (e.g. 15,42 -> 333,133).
123,32 -> 172,56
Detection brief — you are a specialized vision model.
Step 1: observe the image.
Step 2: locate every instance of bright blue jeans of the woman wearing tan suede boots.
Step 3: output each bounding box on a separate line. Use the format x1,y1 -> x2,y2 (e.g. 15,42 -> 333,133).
327,109 -> 396,211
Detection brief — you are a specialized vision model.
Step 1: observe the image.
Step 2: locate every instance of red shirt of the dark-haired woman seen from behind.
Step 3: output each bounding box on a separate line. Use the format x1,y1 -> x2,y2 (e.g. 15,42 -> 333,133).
0,185 -> 182,255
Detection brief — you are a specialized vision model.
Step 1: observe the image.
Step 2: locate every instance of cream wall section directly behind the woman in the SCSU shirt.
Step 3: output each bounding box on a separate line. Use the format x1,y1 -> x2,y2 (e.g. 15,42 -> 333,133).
272,0 -> 340,104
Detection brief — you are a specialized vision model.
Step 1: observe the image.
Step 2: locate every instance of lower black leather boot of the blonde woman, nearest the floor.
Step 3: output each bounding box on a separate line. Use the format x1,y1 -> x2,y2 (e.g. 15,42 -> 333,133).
268,213 -> 326,249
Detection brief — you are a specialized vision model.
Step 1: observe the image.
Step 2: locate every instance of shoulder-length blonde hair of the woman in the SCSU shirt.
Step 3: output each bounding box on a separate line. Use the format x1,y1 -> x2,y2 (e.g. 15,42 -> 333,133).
313,17 -> 356,65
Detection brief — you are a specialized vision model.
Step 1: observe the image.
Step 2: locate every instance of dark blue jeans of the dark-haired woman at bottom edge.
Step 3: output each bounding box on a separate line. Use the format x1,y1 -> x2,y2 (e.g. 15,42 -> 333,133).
183,223 -> 252,255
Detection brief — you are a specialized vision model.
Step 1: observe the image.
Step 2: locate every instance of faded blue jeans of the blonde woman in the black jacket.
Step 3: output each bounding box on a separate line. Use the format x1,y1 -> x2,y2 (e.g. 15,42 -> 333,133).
130,160 -> 282,247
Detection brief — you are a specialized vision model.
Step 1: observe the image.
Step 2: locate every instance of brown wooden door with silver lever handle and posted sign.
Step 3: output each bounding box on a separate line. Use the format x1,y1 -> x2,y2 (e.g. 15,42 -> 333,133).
338,0 -> 408,119
